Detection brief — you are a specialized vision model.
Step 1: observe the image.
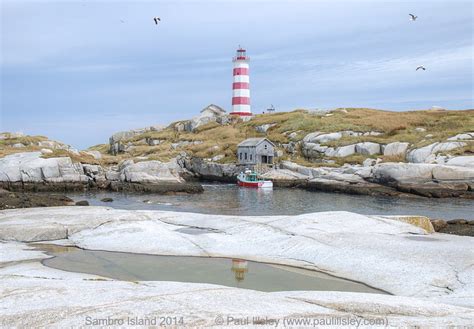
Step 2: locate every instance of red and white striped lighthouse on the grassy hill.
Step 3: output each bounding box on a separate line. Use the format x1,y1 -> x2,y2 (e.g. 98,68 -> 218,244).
230,47 -> 252,116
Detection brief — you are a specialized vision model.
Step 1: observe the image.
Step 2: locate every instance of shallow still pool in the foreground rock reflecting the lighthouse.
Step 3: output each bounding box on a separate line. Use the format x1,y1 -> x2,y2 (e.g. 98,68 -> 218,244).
33,244 -> 384,293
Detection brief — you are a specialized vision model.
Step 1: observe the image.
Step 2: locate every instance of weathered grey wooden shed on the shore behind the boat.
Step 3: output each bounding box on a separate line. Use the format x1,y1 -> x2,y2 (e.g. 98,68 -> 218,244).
237,137 -> 275,165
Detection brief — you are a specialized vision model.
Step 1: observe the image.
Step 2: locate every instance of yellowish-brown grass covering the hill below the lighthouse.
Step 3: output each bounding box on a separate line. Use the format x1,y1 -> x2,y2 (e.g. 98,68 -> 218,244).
0,108 -> 474,167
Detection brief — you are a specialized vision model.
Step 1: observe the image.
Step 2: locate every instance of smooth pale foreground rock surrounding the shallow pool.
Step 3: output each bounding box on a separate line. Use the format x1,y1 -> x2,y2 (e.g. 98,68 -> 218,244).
0,207 -> 474,327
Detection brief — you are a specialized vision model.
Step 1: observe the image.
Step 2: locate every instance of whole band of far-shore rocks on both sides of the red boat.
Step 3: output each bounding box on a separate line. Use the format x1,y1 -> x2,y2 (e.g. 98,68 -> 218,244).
0,152 -> 474,199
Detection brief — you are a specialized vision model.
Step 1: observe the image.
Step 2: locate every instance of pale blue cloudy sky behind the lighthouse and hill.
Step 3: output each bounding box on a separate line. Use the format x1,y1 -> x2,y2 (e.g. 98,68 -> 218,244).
0,0 -> 474,149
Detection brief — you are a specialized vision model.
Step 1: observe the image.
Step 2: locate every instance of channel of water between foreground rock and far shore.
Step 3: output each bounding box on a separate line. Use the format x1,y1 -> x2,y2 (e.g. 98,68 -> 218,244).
70,184 -> 474,219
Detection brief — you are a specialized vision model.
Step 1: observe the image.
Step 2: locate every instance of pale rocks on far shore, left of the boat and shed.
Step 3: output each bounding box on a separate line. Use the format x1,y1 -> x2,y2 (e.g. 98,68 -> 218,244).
0,152 -> 203,194
